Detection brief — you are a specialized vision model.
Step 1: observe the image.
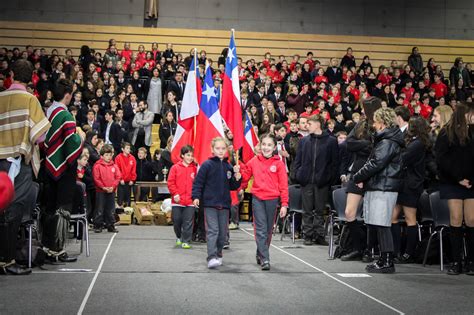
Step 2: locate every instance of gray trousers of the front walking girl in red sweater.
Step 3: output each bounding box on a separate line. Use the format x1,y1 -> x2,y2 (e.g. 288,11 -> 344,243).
252,196 -> 279,261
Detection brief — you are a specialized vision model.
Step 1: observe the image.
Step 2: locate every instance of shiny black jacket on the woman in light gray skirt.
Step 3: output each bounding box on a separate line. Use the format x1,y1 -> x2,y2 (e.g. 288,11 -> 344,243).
353,127 -> 404,192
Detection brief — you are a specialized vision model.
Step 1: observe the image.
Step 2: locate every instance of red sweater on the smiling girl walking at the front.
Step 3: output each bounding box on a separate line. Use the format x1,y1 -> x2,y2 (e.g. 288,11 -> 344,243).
242,154 -> 288,207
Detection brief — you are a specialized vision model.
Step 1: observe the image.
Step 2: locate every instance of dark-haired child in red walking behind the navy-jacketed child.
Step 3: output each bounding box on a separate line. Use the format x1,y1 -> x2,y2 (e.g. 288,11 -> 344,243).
168,145 -> 197,249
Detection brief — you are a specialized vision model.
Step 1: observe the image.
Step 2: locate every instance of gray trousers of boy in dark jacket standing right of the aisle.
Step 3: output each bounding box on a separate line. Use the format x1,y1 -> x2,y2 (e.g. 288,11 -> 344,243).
301,184 -> 329,239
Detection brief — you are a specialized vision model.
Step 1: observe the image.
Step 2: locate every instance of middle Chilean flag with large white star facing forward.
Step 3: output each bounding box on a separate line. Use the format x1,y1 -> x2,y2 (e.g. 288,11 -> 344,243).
194,61 -> 224,164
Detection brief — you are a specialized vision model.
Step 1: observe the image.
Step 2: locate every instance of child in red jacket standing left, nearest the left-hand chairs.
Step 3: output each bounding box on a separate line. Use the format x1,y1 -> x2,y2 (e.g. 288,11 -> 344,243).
92,144 -> 122,233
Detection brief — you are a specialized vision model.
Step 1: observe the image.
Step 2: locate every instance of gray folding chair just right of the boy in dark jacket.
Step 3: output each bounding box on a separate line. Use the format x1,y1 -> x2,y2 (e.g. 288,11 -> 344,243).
328,187 -> 362,259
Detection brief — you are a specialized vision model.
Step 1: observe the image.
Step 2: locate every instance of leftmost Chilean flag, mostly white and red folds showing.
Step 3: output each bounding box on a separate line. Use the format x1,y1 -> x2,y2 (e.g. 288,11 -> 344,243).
171,49 -> 201,163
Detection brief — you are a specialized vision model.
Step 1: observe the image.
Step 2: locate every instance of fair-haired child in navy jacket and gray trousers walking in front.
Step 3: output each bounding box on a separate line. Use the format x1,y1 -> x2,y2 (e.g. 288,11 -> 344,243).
192,138 -> 241,269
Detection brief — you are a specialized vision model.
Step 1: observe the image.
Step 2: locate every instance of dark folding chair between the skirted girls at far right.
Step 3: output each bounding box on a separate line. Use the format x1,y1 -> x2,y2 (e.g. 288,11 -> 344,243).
423,191 -> 449,271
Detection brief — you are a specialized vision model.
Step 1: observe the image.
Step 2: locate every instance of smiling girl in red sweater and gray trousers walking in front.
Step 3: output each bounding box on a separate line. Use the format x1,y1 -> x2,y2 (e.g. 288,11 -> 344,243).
242,134 -> 288,270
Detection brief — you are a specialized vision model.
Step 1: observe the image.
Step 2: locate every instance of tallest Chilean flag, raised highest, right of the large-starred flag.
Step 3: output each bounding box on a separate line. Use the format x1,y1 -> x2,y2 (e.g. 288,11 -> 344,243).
221,30 -> 244,150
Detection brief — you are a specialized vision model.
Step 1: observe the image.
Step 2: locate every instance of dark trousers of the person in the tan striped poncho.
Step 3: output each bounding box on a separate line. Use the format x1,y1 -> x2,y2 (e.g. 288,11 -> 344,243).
0,160 -> 33,263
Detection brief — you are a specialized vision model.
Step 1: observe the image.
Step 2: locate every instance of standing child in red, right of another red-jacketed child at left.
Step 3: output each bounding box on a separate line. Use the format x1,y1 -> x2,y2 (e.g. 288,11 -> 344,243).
115,142 -> 137,207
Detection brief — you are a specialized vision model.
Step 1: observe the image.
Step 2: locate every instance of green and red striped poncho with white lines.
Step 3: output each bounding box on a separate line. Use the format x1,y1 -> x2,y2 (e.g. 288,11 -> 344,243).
44,102 -> 82,180
